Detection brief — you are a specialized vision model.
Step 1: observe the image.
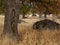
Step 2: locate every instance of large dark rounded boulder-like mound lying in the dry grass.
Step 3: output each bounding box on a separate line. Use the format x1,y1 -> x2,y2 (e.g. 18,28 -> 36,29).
33,19 -> 60,30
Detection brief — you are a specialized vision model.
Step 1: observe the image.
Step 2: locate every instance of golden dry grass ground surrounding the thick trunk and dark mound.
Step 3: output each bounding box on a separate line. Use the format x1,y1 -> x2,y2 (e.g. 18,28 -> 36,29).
0,16 -> 60,45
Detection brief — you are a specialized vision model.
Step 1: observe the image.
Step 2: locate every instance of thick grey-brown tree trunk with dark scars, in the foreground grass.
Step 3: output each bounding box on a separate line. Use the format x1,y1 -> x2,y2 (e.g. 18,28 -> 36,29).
2,0 -> 19,40
